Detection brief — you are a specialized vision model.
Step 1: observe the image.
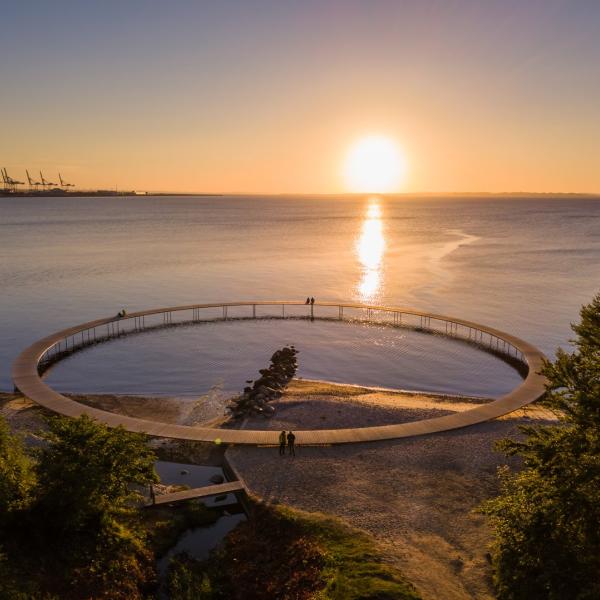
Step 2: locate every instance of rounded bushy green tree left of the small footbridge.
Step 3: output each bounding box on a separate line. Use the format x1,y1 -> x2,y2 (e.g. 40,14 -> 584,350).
29,416 -> 158,599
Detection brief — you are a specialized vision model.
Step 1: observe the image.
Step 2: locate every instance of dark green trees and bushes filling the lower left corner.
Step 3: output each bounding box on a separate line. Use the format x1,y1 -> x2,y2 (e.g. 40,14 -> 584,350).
0,416 -> 157,600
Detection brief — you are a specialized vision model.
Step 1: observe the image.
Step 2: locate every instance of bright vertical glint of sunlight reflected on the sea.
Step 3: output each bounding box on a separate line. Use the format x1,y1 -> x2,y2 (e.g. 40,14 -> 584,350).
356,198 -> 385,300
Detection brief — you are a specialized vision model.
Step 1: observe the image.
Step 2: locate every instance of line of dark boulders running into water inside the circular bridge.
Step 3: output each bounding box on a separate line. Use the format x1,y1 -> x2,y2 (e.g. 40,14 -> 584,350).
228,346 -> 298,419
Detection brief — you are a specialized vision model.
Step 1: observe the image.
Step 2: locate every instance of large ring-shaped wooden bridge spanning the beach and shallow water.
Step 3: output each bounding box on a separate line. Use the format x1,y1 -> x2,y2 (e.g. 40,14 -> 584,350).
12,301 -> 545,445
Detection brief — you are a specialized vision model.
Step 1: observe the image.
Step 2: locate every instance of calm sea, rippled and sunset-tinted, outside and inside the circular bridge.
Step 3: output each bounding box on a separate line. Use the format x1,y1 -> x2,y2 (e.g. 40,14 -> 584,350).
0,195 -> 600,400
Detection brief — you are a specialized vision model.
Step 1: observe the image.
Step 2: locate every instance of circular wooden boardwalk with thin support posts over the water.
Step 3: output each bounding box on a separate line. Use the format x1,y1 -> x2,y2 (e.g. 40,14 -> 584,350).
12,300 -> 545,445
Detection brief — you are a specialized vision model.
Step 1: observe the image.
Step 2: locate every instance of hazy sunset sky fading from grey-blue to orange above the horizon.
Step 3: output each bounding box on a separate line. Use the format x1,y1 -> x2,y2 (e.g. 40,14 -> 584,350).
0,0 -> 600,193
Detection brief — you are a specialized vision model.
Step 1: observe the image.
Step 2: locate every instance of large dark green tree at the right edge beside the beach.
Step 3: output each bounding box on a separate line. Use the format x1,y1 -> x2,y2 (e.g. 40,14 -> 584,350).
482,294 -> 600,600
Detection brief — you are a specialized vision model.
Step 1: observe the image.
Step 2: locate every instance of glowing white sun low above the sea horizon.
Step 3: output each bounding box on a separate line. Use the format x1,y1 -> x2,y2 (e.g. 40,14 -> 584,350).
344,135 -> 406,193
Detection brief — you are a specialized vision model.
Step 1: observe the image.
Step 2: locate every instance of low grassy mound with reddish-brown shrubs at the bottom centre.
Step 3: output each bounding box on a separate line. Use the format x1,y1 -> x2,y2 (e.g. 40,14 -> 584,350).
162,501 -> 420,600
